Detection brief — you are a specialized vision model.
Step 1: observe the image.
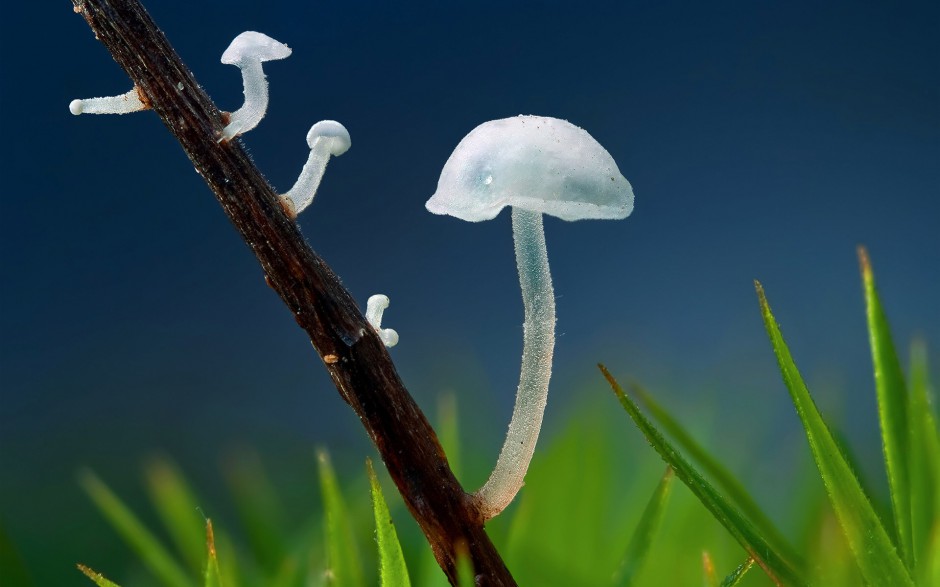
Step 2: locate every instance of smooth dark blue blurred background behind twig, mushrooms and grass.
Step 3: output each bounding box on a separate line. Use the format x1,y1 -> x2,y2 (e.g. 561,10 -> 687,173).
0,0 -> 940,584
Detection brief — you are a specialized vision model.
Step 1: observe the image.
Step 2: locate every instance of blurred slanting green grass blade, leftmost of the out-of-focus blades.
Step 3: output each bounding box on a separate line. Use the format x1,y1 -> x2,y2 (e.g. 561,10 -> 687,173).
79,471 -> 194,587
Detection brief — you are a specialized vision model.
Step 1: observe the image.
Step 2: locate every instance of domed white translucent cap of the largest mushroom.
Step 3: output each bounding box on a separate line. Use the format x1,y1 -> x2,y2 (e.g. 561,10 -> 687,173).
425,116 -> 633,222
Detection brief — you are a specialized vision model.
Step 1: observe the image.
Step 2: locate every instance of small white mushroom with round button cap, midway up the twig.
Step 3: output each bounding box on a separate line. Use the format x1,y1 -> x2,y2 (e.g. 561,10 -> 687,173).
281,120 -> 352,218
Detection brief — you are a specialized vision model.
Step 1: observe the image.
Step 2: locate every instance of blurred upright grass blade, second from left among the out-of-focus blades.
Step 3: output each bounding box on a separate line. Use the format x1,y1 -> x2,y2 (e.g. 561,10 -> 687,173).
144,458 -> 206,574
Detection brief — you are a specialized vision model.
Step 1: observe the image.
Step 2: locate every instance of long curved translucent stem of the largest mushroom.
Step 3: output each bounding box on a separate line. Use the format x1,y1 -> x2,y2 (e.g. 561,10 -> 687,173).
471,207 -> 555,520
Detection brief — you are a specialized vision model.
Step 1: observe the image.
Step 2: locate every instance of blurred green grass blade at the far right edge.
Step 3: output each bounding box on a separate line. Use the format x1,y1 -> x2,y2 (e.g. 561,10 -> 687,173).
907,342 -> 940,567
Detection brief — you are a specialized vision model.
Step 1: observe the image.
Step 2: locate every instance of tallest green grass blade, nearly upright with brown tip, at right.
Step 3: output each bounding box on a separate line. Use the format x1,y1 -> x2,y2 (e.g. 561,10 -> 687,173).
858,247 -> 914,569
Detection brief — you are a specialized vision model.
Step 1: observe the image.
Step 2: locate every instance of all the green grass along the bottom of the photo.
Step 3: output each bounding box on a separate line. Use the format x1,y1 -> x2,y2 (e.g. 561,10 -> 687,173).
77,250 -> 940,587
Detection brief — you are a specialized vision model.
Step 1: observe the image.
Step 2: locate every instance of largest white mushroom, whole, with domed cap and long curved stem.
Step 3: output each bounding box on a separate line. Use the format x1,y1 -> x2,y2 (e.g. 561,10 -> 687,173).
426,116 -> 633,520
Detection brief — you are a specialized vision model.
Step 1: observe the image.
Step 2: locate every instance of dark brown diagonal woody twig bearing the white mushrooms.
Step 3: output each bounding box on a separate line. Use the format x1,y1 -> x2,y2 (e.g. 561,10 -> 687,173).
73,0 -> 515,585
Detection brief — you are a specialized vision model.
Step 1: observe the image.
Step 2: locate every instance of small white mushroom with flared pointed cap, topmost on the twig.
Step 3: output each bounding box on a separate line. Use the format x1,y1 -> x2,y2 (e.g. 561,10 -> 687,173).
219,31 -> 291,143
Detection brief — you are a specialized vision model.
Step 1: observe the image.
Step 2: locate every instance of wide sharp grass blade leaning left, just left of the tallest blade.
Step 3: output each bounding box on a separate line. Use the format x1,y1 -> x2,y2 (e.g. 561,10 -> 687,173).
755,282 -> 913,587
